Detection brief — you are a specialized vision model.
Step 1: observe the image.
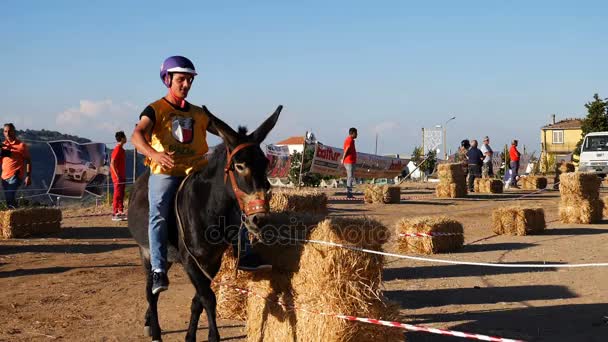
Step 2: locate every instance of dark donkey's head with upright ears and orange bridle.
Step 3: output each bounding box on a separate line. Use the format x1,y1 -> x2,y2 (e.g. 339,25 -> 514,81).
203,106 -> 283,237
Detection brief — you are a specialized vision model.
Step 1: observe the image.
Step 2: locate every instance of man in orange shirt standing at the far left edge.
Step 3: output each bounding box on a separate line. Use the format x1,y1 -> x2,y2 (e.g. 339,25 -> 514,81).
0,123 -> 32,208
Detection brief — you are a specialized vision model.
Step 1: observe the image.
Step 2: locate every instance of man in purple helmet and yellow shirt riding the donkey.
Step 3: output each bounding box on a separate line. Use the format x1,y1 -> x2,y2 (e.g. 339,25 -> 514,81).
131,56 -> 270,295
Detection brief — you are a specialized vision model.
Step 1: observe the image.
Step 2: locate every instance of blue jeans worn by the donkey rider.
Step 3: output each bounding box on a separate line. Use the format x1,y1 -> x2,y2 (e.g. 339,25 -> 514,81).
148,174 -> 184,272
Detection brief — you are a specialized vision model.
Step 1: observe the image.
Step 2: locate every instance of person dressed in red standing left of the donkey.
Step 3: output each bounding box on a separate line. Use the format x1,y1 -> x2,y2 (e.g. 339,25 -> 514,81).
110,131 -> 127,221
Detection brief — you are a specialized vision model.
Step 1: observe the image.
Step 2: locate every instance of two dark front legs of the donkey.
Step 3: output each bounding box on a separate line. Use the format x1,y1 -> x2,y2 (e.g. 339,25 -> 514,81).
184,262 -> 220,342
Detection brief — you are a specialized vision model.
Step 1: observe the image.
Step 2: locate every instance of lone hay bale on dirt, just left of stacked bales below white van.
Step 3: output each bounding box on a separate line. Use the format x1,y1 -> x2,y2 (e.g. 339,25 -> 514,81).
492,206 -> 546,236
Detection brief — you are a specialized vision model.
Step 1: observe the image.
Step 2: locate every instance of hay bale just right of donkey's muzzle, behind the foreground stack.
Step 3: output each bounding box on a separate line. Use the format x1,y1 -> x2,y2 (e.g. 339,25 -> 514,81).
270,189 -> 327,215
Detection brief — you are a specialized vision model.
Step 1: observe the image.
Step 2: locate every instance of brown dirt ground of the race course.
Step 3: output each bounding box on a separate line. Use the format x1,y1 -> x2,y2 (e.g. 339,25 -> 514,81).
0,184 -> 608,342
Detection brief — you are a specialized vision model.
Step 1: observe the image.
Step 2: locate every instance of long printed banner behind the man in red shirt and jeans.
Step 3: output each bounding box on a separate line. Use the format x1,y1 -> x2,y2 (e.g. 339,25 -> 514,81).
310,143 -> 406,178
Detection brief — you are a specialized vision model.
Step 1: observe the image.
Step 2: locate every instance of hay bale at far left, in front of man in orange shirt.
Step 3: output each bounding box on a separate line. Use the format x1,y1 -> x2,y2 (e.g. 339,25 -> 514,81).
0,208 -> 61,239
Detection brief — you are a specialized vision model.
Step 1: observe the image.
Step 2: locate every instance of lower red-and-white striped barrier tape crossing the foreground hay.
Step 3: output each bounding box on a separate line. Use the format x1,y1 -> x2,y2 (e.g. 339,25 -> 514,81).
224,283 -> 523,342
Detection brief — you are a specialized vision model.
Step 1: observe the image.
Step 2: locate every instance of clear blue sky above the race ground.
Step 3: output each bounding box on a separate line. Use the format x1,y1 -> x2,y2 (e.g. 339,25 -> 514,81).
0,0 -> 608,153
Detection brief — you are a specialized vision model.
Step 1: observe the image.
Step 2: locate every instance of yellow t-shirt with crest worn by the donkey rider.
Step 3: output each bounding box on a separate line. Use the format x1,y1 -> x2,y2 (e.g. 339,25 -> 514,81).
148,98 -> 209,176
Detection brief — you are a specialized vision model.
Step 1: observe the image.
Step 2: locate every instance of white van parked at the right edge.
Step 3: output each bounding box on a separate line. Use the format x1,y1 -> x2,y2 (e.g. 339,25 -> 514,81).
578,132 -> 608,176
